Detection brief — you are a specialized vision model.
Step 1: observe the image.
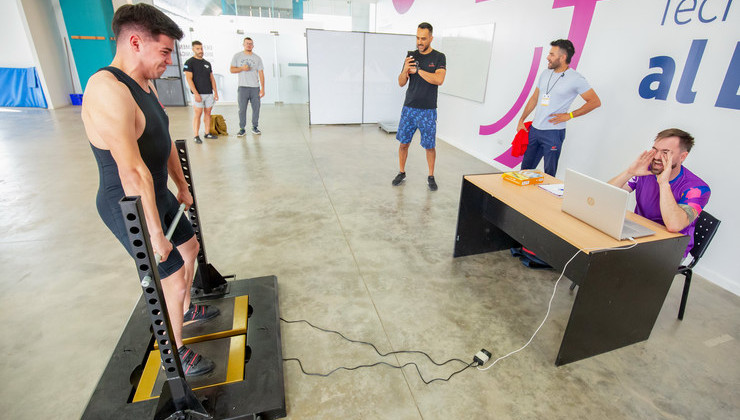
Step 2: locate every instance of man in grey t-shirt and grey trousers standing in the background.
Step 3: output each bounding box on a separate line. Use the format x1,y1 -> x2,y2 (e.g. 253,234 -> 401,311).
230,37 -> 265,137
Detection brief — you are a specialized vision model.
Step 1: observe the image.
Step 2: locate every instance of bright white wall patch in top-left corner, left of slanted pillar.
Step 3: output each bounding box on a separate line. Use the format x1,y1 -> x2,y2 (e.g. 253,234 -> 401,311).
0,0 -> 36,68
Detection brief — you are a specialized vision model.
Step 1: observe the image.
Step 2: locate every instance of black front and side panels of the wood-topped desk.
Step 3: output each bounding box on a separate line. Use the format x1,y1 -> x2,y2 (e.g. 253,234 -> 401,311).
454,177 -> 688,366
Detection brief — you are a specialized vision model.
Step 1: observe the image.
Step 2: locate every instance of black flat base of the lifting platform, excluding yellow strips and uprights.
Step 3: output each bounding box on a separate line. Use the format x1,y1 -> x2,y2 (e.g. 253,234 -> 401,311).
82,276 -> 286,420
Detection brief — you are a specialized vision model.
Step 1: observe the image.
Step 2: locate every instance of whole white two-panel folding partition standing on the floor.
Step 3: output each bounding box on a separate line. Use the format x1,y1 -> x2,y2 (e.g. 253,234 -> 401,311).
306,29 -> 415,124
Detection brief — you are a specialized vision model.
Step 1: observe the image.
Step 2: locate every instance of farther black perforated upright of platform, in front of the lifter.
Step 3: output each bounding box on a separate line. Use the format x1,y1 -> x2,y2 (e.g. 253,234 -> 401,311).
175,140 -> 234,298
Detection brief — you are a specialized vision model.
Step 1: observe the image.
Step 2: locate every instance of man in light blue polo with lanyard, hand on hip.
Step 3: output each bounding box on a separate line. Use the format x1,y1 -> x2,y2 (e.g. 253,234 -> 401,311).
517,39 -> 601,176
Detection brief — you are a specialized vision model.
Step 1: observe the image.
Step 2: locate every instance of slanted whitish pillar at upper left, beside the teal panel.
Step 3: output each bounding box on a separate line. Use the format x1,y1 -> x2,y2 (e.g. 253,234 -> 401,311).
19,0 -> 74,109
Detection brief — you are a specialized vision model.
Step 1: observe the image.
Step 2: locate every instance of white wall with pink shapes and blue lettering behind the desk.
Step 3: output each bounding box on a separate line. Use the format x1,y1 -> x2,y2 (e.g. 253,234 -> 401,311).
376,0 -> 740,294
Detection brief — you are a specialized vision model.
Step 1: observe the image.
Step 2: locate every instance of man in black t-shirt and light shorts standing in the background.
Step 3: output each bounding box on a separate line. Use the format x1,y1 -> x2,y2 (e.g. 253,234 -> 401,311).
183,41 -> 218,143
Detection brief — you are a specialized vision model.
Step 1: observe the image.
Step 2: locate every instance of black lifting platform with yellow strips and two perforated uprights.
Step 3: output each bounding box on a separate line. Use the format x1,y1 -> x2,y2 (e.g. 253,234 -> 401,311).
82,140 -> 286,420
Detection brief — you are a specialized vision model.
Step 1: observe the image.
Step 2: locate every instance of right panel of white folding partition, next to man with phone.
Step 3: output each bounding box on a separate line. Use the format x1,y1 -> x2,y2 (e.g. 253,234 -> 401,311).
362,33 -> 416,123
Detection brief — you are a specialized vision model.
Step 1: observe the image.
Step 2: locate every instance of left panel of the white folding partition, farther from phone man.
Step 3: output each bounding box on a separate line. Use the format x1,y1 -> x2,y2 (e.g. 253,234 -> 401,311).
306,29 -> 365,124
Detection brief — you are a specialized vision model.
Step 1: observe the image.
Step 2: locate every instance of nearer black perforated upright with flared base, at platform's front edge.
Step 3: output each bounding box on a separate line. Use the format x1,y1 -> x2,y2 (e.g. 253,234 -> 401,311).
119,196 -> 212,420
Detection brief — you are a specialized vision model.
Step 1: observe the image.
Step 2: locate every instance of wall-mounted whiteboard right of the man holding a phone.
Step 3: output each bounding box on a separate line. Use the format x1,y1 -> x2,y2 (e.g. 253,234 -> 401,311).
434,23 -> 495,103
